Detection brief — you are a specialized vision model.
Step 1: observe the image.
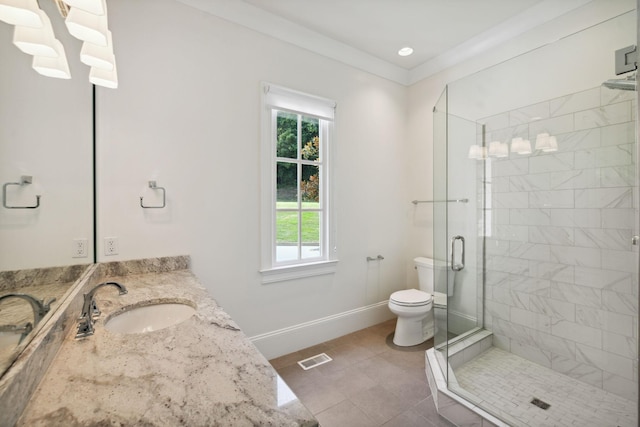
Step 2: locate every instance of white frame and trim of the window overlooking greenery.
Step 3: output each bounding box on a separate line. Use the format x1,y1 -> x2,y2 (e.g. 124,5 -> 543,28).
260,82 -> 338,283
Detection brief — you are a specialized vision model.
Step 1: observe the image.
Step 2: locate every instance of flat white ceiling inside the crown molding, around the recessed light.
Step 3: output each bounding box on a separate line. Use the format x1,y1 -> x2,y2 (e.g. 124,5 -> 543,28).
244,0 -> 542,70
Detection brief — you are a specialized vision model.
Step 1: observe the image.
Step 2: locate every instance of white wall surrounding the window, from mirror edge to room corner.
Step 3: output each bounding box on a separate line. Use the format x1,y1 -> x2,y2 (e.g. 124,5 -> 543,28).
98,0 -> 413,356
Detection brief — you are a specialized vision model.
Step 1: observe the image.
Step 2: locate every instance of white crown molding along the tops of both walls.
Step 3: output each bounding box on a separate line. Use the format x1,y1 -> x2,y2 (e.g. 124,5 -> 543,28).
177,0 -> 635,86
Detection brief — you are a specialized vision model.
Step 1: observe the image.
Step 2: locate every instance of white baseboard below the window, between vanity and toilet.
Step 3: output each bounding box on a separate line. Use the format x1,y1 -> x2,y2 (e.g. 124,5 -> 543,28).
249,301 -> 395,360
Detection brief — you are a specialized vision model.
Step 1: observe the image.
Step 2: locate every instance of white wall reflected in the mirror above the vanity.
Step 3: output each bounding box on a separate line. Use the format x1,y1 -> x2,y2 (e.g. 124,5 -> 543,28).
0,2 -> 93,271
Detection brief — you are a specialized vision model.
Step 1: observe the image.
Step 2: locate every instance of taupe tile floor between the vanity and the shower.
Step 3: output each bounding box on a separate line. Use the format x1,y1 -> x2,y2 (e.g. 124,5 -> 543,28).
270,319 -> 453,427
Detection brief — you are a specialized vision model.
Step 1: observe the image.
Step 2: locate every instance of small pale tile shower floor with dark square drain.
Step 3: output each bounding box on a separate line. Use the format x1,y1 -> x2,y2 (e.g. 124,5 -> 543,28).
454,347 -> 637,427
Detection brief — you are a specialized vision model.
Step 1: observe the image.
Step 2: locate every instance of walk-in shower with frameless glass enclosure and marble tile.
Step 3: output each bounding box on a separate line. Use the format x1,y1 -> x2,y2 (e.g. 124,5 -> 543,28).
427,6 -> 640,426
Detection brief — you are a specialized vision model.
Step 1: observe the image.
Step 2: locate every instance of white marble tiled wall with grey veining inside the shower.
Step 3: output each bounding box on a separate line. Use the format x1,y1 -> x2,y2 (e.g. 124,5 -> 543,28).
478,87 -> 638,399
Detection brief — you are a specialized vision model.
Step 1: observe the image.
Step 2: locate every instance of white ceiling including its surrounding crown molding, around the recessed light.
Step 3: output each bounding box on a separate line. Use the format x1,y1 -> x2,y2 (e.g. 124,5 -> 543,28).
178,0 -> 592,84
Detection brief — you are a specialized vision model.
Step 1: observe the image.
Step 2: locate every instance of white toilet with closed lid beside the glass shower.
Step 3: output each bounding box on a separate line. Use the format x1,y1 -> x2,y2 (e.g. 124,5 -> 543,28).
389,257 -> 455,347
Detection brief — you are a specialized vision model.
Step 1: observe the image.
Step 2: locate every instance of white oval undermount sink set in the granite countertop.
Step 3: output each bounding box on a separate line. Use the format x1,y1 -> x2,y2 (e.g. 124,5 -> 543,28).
105,302 -> 196,334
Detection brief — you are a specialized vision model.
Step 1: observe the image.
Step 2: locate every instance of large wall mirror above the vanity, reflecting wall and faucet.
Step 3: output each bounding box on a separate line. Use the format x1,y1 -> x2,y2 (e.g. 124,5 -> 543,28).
0,2 -> 94,376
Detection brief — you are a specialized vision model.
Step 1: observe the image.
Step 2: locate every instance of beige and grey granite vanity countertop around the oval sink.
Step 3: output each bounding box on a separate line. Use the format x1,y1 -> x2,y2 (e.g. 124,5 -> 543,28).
17,270 -> 318,427
